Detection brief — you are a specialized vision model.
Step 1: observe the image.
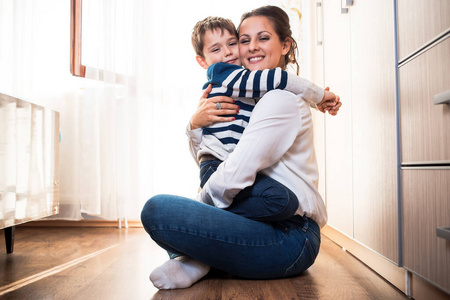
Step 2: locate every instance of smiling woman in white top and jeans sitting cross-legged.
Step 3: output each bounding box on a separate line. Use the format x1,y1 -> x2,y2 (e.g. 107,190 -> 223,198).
142,6 -> 339,289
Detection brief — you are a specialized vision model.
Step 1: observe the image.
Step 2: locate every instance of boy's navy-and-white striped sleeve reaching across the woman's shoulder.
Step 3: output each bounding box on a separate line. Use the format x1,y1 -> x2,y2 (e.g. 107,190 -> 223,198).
207,63 -> 324,107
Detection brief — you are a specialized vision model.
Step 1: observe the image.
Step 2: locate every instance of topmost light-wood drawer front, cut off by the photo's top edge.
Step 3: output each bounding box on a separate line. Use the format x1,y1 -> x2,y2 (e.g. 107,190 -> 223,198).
397,0 -> 450,61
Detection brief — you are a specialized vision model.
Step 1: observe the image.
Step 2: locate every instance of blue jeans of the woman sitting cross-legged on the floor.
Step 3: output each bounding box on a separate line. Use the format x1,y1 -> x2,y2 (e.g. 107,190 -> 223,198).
141,195 -> 320,279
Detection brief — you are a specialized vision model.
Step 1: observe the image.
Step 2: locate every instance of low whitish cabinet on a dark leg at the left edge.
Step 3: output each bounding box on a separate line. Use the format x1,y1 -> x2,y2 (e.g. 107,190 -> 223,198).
0,94 -> 59,252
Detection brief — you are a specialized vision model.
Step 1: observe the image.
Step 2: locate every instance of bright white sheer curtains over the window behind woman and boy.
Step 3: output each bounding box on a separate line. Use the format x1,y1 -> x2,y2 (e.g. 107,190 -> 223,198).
0,0 -> 300,219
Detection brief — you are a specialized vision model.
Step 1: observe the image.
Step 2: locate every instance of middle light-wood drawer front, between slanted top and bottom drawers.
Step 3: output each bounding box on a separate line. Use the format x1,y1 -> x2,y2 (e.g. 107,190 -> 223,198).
399,37 -> 450,164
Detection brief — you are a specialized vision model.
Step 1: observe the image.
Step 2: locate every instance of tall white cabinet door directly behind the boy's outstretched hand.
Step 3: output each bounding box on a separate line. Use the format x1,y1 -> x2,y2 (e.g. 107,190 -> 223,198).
323,0 -> 353,237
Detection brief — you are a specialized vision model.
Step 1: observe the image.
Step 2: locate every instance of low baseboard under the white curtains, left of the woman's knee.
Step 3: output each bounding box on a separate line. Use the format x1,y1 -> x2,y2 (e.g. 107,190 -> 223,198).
19,219 -> 142,228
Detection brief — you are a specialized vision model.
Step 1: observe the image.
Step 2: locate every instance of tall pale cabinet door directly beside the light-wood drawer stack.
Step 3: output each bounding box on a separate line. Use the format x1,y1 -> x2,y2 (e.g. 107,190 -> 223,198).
350,1 -> 398,262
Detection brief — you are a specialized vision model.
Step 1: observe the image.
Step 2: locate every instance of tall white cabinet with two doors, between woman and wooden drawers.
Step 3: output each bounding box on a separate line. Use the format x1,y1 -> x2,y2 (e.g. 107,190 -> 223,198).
323,0 -> 398,262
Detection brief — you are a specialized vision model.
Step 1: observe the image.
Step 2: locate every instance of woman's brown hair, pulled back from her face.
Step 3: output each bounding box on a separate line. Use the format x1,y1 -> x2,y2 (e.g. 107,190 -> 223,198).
238,5 -> 300,75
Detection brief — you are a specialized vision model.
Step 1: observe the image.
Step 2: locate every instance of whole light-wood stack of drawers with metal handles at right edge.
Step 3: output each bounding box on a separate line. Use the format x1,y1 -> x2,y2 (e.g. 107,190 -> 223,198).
398,0 -> 450,297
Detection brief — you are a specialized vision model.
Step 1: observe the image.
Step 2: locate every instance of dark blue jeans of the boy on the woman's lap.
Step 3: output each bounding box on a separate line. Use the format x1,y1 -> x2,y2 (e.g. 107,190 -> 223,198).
200,159 -> 299,221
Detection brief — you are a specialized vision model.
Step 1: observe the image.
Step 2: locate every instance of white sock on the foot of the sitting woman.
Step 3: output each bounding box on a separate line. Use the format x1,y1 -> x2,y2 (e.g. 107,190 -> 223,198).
150,256 -> 210,290
